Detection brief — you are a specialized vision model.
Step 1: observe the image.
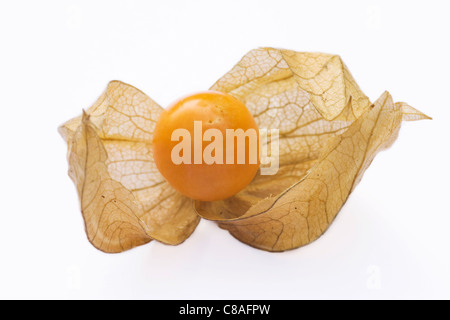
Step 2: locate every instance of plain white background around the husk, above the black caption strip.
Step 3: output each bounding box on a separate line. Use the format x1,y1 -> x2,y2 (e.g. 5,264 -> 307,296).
0,0 -> 450,299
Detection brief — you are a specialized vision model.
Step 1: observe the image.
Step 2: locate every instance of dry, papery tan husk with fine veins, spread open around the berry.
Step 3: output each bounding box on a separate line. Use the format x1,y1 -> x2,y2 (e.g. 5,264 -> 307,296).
60,48 -> 429,253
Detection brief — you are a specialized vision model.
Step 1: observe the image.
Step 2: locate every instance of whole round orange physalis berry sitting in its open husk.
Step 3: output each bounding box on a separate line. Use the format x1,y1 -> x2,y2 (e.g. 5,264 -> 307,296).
153,91 -> 259,201
